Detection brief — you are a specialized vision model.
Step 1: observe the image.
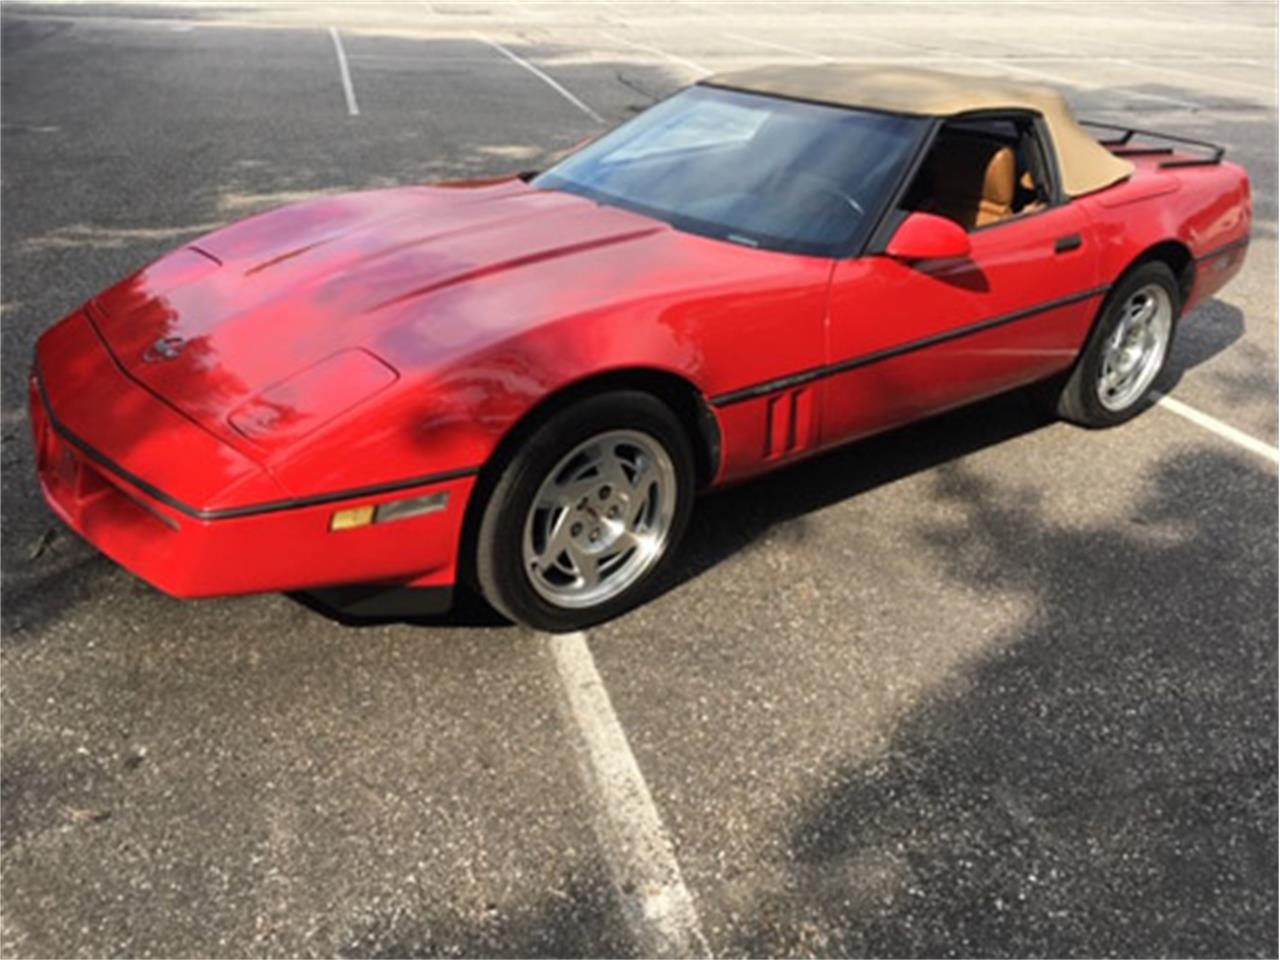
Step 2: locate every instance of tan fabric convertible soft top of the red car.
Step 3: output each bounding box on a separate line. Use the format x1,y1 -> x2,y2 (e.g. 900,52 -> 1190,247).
703,63 -> 1133,197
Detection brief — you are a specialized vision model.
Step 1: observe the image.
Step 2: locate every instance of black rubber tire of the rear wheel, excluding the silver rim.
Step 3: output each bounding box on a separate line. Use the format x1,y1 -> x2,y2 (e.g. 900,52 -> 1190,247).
1057,260 -> 1181,429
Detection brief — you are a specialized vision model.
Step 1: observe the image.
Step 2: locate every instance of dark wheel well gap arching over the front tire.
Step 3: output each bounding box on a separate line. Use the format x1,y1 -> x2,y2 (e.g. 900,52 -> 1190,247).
458,367 -> 721,591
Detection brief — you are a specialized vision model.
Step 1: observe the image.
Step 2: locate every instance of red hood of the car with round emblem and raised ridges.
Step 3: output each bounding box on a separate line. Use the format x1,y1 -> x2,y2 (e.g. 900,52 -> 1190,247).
91,179 -> 669,455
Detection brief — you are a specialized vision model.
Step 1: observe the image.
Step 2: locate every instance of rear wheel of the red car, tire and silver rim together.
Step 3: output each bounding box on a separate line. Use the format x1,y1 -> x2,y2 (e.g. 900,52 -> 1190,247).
1057,262 -> 1181,426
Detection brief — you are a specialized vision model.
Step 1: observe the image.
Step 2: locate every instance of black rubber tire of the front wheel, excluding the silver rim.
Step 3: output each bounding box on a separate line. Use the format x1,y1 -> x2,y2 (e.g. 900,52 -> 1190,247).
475,390 -> 695,632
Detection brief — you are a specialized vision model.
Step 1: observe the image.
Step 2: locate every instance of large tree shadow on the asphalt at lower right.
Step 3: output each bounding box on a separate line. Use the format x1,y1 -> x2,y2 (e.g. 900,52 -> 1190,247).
724,451 -> 1277,956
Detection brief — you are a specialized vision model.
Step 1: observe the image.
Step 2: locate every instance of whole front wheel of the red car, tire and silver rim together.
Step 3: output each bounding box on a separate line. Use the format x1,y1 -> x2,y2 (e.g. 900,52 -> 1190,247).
476,392 -> 694,631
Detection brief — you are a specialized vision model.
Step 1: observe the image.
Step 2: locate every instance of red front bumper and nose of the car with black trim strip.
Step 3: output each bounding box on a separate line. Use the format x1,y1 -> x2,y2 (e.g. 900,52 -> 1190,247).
29,323 -> 475,596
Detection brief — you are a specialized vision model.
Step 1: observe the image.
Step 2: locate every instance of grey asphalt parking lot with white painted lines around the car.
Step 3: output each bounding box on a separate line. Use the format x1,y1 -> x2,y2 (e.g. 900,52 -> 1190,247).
0,0 -> 1277,956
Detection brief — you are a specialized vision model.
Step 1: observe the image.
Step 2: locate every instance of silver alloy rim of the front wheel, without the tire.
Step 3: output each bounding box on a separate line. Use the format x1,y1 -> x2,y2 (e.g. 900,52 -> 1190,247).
522,430 -> 677,608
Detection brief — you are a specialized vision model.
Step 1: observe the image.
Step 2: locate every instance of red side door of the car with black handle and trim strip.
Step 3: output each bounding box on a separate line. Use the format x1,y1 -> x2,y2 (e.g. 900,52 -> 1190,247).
822,112 -> 1103,444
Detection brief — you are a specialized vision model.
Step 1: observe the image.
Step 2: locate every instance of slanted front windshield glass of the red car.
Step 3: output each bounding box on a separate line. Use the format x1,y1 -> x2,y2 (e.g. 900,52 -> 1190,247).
532,86 -> 927,256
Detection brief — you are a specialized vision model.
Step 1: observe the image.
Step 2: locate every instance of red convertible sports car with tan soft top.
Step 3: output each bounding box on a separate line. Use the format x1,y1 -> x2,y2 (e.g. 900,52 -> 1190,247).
31,64 -> 1251,630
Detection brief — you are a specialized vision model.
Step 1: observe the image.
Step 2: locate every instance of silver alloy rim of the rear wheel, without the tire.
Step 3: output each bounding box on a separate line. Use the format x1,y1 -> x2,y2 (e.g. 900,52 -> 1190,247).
1098,283 -> 1174,412
